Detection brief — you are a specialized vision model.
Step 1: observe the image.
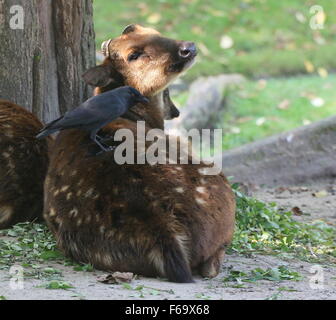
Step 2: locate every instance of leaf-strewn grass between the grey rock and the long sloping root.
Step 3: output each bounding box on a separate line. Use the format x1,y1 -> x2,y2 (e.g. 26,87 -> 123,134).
218,75 -> 336,149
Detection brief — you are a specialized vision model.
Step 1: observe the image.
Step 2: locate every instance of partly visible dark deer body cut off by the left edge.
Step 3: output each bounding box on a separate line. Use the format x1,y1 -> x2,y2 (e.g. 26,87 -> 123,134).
0,100 -> 52,229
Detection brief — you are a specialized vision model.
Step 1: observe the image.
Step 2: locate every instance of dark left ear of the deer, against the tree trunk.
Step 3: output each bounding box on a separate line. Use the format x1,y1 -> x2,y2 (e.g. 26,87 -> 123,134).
83,64 -> 123,87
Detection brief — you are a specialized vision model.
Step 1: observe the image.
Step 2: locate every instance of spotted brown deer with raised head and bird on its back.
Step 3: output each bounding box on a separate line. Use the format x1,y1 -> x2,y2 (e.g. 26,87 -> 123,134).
44,25 -> 235,283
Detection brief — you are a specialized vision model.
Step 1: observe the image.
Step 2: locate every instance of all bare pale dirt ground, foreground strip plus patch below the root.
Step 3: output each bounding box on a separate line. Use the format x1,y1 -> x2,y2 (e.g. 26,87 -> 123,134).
0,186 -> 336,300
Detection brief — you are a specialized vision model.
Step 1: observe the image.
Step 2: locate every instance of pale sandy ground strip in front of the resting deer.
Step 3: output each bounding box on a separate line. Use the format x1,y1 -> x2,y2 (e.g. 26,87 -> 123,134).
0,255 -> 336,300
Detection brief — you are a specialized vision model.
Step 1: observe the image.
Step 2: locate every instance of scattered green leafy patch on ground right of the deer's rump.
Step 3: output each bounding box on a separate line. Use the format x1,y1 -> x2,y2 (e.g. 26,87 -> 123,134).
230,185 -> 336,263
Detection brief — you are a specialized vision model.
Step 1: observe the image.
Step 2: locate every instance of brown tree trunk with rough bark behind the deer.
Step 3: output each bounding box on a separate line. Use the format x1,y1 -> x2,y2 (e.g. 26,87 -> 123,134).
0,0 -> 95,122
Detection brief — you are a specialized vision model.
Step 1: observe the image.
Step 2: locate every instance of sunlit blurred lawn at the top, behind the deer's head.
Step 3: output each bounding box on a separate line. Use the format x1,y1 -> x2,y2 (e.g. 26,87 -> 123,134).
94,0 -> 336,79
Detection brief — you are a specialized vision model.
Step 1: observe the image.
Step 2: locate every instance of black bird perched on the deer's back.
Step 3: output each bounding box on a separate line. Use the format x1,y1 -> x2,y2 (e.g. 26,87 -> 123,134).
36,86 -> 149,151
